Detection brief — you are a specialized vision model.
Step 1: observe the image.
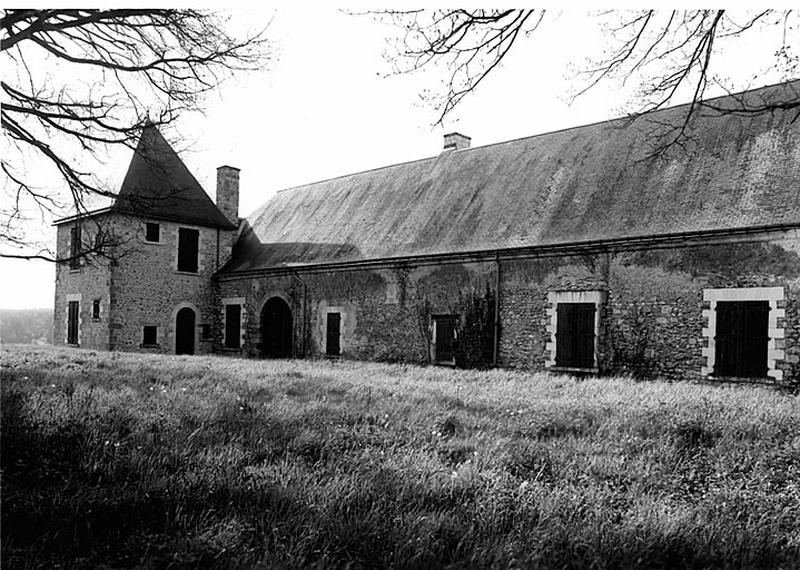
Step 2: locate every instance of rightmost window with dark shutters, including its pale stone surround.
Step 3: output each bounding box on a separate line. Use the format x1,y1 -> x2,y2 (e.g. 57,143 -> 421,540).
701,287 -> 786,380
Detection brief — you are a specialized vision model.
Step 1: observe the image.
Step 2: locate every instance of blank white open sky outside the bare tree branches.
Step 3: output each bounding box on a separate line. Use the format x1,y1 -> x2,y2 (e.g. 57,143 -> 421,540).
0,8 -> 792,308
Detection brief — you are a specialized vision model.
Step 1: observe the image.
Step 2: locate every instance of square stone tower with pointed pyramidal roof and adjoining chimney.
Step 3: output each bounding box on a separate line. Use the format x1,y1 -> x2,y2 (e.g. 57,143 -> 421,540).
54,124 -> 239,354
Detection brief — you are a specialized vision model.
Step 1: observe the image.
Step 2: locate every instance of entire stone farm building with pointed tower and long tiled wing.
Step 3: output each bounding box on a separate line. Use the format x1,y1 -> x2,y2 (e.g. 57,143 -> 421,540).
55,81 -> 800,385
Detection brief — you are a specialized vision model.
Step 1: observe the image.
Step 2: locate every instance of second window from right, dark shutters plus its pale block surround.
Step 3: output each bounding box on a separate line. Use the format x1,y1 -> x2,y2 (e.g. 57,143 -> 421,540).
545,291 -> 605,372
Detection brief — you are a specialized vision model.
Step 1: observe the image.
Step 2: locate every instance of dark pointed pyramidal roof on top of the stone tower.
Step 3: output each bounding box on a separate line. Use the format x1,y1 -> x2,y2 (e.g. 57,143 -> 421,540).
113,125 -> 236,229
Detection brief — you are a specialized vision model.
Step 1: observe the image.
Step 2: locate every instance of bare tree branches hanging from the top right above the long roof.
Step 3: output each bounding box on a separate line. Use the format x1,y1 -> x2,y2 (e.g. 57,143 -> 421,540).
370,9 -> 800,145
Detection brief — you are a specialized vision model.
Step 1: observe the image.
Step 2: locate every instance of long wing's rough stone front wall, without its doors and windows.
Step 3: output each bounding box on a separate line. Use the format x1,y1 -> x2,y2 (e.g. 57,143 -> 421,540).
215,231 -> 800,384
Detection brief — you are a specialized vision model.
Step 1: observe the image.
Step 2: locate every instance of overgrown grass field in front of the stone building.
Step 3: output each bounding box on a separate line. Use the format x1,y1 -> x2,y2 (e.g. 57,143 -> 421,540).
2,347 -> 800,568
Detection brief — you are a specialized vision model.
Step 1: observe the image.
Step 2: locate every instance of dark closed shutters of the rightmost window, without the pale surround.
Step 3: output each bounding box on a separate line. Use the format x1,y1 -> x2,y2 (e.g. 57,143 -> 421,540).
714,301 -> 769,378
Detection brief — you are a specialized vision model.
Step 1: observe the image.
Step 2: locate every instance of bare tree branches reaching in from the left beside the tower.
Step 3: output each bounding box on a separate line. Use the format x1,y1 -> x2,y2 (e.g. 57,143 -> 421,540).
0,9 -> 270,259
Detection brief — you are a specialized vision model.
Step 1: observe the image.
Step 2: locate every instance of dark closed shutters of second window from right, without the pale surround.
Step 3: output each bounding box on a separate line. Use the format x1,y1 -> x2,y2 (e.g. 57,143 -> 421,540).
556,303 -> 596,368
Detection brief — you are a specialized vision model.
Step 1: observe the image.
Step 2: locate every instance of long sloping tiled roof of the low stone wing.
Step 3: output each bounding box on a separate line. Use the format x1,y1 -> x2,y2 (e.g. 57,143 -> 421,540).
224,81 -> 800,271
